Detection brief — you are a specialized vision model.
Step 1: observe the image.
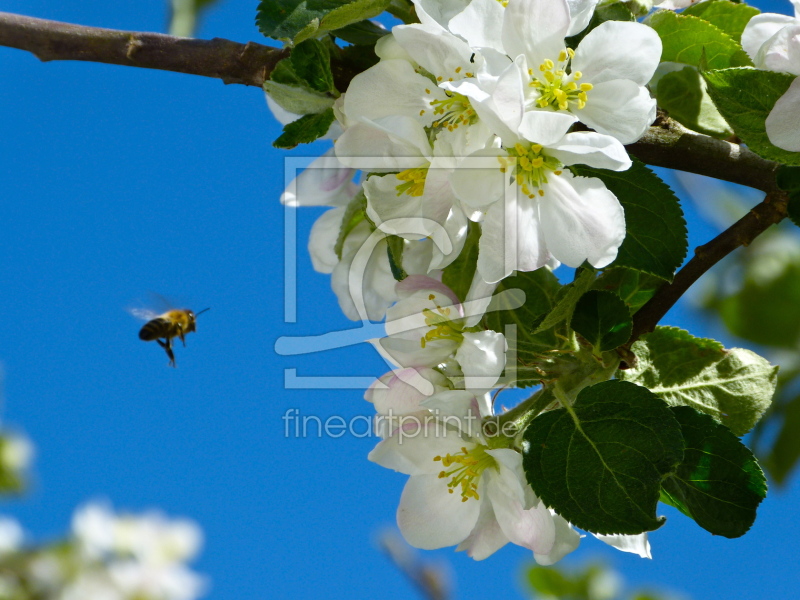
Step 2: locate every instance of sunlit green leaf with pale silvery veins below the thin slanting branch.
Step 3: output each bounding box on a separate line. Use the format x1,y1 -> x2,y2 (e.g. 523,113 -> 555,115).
617,327 -> 778,435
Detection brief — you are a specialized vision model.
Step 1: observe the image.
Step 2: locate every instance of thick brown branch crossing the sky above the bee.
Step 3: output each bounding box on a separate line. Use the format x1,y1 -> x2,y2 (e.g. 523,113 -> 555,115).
0,12 -> 288,87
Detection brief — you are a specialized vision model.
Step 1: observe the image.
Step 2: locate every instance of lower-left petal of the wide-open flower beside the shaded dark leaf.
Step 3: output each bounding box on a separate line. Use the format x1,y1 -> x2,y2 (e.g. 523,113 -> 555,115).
478,192 -> 551,283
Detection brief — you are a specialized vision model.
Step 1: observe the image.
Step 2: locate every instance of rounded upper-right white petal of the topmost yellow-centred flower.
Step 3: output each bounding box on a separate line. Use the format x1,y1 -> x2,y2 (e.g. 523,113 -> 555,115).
572,21 -> 661,85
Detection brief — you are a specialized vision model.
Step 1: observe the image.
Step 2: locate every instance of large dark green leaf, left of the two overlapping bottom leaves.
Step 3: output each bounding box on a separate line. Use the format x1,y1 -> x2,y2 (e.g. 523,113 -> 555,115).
522,381 -> 683,534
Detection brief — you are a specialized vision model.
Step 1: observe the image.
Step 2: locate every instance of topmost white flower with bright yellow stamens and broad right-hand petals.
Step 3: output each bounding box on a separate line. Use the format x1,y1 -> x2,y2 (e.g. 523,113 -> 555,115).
490,0 -> 661,144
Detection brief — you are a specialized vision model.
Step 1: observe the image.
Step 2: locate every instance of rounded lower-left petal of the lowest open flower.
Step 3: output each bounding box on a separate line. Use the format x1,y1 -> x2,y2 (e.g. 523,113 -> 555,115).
397,475 -> 480,550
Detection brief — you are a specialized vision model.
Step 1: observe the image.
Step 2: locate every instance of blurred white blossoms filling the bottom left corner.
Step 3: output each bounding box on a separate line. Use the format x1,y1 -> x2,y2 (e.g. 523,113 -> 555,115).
0,504 -> 206,600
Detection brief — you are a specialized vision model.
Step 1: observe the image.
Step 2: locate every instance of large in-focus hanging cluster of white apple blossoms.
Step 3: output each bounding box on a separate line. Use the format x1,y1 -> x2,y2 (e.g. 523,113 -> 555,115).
282,0 -> 672,564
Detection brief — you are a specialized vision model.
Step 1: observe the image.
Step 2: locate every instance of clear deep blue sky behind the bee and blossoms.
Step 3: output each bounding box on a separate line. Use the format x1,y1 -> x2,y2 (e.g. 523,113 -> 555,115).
0,0 -> 800,600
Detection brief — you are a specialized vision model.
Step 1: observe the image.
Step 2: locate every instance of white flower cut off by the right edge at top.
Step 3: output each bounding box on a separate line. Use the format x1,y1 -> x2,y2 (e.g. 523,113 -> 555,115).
742,0 -> 800,152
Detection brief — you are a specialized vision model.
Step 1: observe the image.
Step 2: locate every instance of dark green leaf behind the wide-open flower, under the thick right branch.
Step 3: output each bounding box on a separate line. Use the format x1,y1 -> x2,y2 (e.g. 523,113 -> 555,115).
570,160 -> 688,281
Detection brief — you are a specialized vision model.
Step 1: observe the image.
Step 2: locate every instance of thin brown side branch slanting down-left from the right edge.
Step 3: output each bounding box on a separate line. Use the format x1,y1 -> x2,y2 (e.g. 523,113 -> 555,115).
623,191 -> 789,346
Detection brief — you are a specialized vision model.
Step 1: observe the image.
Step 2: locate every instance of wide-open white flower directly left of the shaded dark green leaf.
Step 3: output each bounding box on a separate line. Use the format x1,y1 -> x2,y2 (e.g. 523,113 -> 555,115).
451,61 -> 630,283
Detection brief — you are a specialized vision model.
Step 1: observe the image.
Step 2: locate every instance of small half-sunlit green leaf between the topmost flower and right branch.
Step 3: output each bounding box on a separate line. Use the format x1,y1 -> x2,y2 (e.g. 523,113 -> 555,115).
656,67 -> 733,138
